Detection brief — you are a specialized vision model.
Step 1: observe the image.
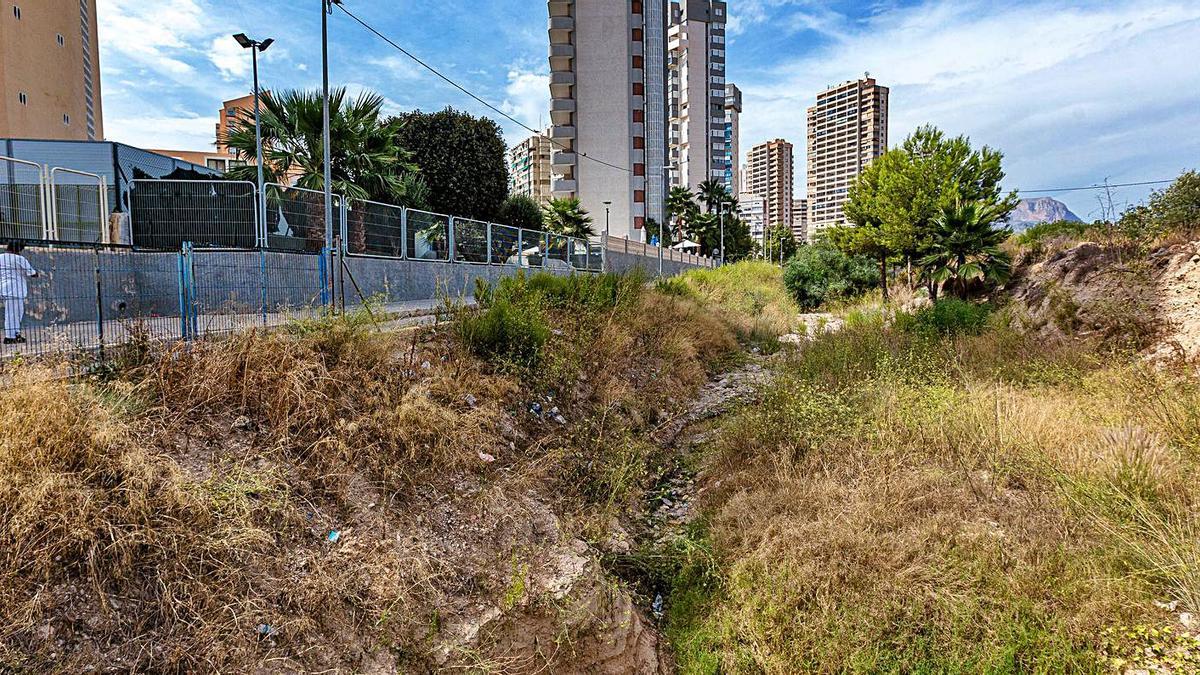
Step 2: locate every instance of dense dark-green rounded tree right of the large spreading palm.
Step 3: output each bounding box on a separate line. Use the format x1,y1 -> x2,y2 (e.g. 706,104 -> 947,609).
396,108 -> 509,220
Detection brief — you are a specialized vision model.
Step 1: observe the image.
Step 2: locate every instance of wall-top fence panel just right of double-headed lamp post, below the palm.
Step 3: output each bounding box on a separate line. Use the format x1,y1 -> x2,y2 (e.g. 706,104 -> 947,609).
264,183 -> 342,253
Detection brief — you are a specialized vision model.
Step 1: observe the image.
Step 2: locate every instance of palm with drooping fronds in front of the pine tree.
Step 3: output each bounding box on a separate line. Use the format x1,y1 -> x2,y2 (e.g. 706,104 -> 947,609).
920,196 -> 1013,300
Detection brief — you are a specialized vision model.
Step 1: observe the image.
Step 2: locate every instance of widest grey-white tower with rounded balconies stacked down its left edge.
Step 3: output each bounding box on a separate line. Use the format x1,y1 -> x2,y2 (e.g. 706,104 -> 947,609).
547,0 -> 668,240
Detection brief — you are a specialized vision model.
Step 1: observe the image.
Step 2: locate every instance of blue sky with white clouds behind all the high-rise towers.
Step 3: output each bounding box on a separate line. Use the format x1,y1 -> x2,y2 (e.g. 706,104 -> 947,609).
98,0 -> 1200,219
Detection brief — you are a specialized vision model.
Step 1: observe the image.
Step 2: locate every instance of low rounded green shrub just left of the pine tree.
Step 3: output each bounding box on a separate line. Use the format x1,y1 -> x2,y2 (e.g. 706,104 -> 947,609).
784,244 -> 878,310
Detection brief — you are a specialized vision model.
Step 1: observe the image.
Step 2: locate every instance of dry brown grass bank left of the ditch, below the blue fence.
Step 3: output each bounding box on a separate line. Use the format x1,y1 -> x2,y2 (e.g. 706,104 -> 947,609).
0,270 -> 737,673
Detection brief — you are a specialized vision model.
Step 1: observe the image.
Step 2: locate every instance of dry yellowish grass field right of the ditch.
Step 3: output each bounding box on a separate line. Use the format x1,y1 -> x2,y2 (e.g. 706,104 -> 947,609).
671,312 -> 1200,673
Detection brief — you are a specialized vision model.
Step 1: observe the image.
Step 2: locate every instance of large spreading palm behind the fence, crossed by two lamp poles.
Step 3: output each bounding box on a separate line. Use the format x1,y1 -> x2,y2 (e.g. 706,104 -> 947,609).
223,88 -> 428,208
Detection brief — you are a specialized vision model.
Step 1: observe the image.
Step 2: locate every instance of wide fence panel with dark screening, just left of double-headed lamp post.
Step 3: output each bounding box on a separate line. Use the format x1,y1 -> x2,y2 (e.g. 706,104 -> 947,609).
130,180 -> 259,250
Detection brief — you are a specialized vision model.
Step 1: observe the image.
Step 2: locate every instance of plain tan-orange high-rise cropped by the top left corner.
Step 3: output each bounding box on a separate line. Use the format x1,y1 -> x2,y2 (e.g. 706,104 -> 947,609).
0,0 -> 104,141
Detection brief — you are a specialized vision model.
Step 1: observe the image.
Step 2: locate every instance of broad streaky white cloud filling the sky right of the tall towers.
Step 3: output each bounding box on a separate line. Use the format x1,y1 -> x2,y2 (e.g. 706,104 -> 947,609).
732,0 -> 1200,211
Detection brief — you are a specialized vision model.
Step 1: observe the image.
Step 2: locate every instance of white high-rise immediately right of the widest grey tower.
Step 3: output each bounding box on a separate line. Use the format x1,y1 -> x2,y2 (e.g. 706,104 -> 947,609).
667,0 -> 742,191
